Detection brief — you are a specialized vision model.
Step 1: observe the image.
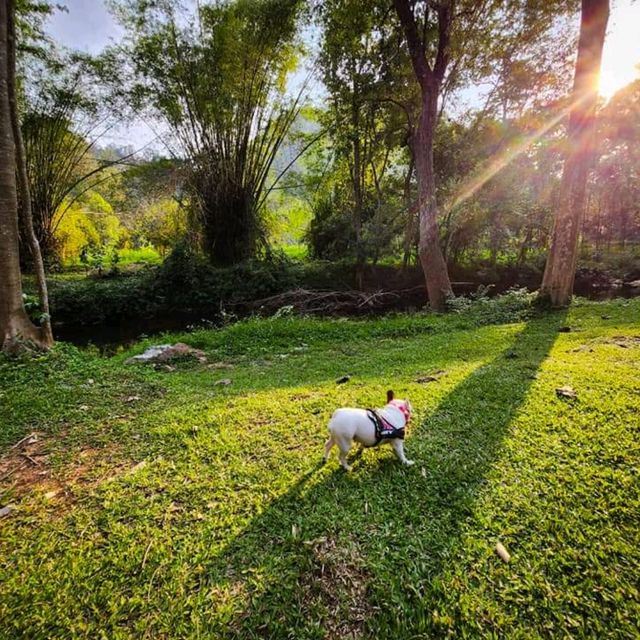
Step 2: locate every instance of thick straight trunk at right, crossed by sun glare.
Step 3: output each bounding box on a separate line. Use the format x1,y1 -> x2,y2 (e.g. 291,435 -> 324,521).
540,0 -> 609,307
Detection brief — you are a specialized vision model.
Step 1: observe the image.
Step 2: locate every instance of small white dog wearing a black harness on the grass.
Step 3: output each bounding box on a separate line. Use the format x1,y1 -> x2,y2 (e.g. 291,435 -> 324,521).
323,391 -> 413,471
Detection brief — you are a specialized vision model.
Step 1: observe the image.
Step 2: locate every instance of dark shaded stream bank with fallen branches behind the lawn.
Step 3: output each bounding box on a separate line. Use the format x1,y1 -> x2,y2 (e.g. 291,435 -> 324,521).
27,252 -> 640,352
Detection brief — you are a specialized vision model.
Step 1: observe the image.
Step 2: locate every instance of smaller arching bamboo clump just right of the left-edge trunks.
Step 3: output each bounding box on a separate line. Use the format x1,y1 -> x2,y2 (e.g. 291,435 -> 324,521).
21,38 -> 127,266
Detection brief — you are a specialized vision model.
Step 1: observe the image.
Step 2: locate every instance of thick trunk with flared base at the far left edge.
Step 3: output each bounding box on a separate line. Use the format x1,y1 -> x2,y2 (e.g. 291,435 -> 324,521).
0,0 -> 47,350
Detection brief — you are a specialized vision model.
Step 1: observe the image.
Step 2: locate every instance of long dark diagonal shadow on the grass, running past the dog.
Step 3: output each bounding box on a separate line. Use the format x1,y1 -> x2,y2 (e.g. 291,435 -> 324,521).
188,313 -> 564,639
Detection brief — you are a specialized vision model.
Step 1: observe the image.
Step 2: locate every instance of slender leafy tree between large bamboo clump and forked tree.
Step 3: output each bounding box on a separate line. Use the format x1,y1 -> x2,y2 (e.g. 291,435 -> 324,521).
318,0 -> 406,287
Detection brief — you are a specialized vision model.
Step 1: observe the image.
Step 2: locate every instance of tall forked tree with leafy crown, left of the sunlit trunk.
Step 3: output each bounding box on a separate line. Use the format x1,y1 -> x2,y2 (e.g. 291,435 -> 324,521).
394,0 -> 575,309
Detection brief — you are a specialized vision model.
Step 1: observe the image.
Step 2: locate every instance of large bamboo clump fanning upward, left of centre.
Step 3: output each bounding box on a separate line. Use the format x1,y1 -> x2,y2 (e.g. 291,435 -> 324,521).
119,0 -> 300,265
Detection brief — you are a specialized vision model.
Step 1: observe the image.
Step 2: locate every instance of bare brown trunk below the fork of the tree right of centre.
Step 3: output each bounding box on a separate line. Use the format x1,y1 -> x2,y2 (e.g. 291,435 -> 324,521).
413,88 -> 452,311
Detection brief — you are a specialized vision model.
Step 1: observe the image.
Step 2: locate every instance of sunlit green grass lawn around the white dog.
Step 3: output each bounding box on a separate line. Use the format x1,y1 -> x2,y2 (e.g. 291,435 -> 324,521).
0,299 -> 640,640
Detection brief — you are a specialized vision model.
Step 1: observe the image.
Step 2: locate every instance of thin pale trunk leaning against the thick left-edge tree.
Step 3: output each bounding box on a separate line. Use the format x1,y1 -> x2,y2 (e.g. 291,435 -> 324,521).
8,0 -> 53,346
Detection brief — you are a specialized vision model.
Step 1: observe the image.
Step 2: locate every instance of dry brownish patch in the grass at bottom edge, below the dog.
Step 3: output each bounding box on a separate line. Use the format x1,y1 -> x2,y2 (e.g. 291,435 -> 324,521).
299,538 -> 368,640
